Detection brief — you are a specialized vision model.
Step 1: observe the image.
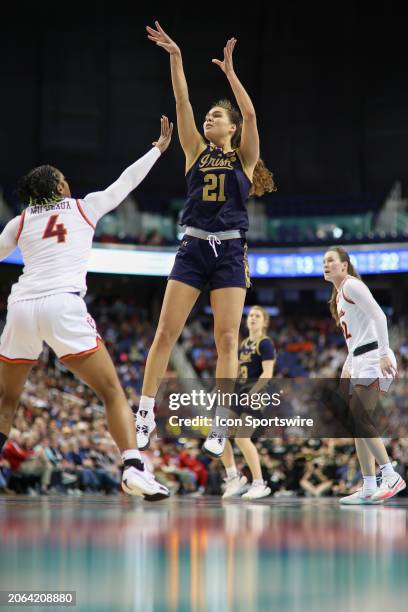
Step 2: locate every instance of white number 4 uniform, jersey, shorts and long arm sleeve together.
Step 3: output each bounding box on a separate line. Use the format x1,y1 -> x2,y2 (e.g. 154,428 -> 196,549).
0,147 -> 160,363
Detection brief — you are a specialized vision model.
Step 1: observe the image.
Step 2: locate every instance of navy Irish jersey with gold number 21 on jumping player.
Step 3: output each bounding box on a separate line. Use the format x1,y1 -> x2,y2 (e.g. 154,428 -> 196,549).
181,145 -> 252,232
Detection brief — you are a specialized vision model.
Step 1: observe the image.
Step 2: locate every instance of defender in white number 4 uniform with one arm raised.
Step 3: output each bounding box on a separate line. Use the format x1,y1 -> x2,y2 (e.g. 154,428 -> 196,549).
0,117 -> 173,501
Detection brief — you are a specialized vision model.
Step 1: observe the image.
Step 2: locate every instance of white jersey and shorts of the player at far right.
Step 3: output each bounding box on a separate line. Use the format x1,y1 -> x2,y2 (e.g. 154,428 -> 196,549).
337,276 -> 397,391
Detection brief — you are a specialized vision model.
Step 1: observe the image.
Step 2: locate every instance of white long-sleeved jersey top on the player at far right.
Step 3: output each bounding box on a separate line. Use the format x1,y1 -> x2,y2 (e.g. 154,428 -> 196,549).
337,276 -> 389,357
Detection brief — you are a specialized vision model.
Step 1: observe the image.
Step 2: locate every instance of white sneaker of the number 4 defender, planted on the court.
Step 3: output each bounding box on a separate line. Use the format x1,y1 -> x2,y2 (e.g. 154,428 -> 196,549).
122,459 -> 170,501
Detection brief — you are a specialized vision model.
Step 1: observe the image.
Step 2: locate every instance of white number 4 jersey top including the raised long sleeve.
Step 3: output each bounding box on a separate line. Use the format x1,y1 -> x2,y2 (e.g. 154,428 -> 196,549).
0,147 -> 160,304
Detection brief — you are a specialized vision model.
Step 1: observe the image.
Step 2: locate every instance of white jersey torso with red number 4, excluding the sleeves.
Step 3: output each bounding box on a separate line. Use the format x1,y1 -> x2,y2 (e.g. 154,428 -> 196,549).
9,198 -> 95,303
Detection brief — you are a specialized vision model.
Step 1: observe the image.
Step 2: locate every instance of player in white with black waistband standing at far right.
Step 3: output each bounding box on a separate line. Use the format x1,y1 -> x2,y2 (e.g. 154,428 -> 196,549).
323,247 -> 406,504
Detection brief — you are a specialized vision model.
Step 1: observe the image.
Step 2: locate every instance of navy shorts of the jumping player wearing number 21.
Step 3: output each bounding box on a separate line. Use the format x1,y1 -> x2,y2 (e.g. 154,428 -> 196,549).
169,235 -> 251,291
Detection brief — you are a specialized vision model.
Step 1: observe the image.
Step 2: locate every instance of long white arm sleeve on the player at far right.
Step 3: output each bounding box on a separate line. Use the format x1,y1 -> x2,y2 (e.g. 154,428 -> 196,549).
344,279 -> 389,357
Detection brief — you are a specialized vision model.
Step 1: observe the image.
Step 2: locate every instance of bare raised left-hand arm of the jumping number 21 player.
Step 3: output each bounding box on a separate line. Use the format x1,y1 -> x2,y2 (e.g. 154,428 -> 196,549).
146,21 -> 205,169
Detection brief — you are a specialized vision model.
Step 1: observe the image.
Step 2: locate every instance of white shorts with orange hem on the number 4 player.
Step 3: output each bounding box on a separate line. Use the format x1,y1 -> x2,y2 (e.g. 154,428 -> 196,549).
0,293 -> 101,363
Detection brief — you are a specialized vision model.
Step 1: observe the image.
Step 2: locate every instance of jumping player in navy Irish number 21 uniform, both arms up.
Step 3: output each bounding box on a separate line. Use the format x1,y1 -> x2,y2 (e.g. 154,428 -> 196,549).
136,21 -> 275,454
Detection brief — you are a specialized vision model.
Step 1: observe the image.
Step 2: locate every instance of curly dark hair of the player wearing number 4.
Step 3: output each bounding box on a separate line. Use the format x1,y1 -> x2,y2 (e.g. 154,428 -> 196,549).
17,165 -> 61,206
